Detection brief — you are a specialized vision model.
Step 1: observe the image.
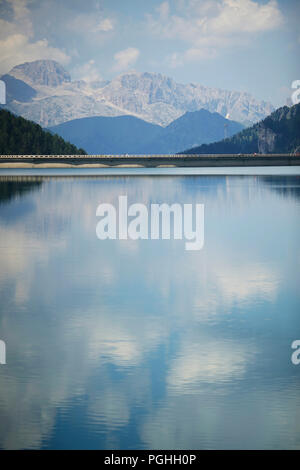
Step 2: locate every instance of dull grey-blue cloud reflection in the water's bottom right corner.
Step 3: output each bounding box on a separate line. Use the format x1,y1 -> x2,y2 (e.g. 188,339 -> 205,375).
140,384 -> 300,450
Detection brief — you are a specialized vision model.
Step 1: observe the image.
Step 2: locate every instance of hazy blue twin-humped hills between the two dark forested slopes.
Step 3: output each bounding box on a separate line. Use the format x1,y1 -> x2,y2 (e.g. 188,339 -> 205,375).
50,109 -> 243,154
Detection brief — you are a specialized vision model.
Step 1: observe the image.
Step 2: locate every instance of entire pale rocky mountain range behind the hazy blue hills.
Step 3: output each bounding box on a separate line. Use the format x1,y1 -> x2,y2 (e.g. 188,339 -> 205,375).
2,60 -> 273,126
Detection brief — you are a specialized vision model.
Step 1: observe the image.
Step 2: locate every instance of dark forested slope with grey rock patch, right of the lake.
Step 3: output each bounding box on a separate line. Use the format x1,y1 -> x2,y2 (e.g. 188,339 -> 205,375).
181,103 -> 300,154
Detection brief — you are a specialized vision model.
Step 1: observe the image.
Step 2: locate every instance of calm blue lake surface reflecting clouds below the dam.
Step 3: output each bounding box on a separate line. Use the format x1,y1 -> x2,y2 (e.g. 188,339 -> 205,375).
0,173 -> 300,449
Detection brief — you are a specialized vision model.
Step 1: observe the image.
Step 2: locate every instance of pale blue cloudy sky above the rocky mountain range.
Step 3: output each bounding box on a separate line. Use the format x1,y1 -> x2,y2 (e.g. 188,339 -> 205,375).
0,0 -> 300,106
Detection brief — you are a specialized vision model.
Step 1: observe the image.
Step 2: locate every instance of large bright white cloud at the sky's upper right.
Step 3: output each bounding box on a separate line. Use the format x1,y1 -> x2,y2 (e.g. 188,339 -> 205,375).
147,0 -> 283,67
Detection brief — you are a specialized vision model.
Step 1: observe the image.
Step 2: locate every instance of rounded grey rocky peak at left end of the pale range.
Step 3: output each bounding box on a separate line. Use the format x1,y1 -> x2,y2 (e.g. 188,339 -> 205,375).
9,60 -> 71,87
